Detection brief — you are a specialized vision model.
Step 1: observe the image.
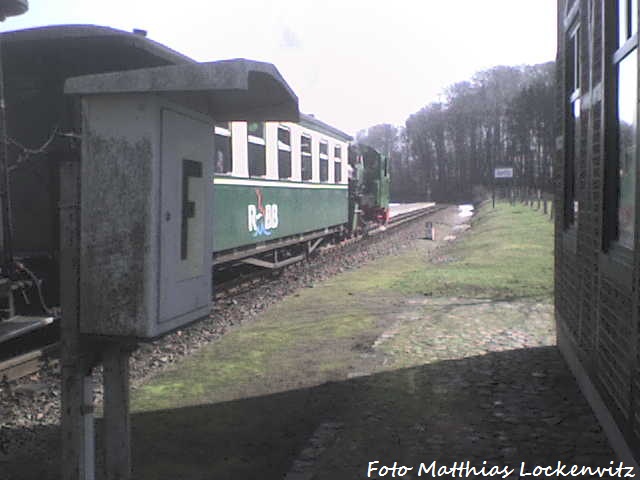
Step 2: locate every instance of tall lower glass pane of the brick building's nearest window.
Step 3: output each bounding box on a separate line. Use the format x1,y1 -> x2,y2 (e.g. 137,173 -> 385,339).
617,49 -> 638,248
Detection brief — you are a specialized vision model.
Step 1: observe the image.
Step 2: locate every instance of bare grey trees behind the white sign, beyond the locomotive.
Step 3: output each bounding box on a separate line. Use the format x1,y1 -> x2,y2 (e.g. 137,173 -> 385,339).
356,62 -> 555,202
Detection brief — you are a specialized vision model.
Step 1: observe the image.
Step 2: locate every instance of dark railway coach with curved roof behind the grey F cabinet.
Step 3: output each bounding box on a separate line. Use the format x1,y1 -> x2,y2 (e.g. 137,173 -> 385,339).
0,25 -> 195,347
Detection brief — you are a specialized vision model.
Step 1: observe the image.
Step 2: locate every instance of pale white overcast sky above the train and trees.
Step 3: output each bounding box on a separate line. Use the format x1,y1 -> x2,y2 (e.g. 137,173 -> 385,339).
0,0 -> 556,134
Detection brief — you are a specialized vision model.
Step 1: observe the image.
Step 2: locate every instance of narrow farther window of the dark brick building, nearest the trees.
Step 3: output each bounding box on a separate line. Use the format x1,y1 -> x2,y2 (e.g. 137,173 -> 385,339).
564,25 -> 581,227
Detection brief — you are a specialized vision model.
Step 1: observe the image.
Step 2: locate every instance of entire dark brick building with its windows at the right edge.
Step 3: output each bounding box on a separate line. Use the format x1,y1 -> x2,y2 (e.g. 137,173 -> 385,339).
555,0 -> 640,461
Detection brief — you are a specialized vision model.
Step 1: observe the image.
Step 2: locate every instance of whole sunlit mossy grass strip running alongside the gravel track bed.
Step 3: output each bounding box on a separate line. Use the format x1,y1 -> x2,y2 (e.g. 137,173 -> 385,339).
132,204 -> 553,411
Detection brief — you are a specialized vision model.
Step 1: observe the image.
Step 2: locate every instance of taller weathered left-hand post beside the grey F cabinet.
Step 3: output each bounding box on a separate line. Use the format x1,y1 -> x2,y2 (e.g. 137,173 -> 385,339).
60,158 -> 95,480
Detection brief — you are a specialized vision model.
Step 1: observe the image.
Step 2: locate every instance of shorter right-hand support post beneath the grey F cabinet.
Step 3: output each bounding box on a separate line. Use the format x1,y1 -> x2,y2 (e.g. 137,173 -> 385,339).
102,343 -> 131,480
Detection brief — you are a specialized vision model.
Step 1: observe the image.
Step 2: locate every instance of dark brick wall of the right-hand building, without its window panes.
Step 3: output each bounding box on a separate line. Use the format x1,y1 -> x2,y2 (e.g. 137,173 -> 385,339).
554,0 -> 640,459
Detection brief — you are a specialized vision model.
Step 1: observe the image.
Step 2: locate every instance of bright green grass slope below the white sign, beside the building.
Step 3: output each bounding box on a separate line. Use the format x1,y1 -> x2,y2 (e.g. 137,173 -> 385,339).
390,204 -> 553,300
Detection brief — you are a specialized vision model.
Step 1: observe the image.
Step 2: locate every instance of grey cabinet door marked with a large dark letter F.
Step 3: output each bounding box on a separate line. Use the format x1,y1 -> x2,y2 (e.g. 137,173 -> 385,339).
158,109 -> 213,333
